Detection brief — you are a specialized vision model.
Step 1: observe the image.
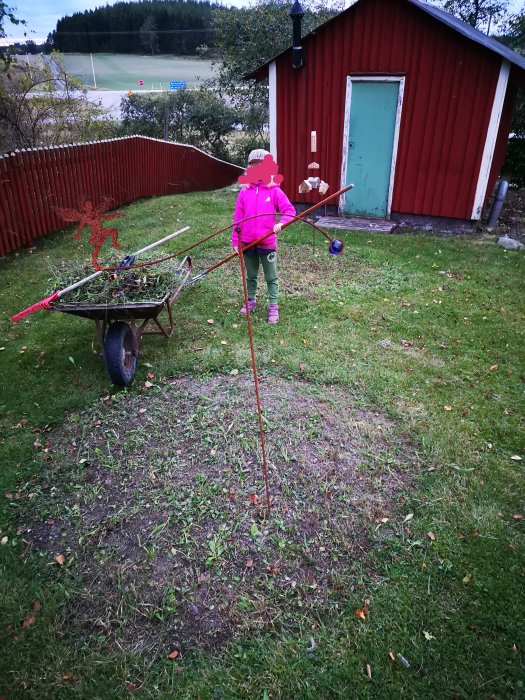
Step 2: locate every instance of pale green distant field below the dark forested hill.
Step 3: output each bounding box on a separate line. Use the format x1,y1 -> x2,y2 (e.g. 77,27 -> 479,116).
60,53 -> 213,92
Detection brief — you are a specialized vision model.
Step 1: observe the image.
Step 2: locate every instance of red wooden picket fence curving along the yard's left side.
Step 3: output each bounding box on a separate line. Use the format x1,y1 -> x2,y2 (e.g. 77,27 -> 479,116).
0,136 -> 243,256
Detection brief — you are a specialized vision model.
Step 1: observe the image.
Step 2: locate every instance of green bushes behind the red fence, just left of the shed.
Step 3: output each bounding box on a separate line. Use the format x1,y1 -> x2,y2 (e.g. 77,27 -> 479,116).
121,88 -> 238,158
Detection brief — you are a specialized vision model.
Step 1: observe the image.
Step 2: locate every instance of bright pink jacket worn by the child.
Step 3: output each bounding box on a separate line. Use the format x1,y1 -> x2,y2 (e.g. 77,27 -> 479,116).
232,182 -> 295,250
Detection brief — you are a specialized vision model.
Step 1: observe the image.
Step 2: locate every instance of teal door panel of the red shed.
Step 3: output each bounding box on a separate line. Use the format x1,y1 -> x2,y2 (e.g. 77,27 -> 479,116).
344,80 -> 400,217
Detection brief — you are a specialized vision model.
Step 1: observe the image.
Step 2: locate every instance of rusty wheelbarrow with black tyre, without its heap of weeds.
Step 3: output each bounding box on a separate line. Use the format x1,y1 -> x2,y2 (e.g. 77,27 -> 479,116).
50,256 -> 191,386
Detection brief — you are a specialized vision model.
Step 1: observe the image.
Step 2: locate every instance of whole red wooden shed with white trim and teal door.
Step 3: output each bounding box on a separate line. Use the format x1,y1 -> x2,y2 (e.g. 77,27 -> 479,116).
250,0 -> 525,220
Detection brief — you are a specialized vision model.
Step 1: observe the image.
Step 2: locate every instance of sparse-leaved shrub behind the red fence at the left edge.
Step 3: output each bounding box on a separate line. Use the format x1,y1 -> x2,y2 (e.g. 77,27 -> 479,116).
0,54 -> 113,153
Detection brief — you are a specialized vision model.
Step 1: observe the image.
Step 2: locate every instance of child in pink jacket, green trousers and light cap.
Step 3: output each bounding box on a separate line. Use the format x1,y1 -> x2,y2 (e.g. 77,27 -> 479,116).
232,148 -> 295,323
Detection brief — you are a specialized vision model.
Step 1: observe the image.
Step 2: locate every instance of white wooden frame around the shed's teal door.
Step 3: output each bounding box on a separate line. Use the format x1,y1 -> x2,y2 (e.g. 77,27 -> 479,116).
339,74 -> 405,217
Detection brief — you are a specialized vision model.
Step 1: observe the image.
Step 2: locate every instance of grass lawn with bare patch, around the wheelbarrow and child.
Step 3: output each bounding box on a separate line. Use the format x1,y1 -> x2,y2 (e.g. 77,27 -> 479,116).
0,189 -> 525,700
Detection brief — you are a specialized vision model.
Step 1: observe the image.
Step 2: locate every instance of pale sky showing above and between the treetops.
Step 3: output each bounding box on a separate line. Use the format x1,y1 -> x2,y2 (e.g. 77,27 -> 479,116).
5,0 -> 523,44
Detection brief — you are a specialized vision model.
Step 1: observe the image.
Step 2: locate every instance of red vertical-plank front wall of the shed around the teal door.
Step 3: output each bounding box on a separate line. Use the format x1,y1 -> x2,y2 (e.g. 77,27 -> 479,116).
277,0 -> 501,219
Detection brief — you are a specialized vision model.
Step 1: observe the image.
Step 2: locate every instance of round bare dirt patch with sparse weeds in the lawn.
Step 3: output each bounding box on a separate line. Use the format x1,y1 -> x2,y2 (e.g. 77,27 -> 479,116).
23,375 -> 418,653
